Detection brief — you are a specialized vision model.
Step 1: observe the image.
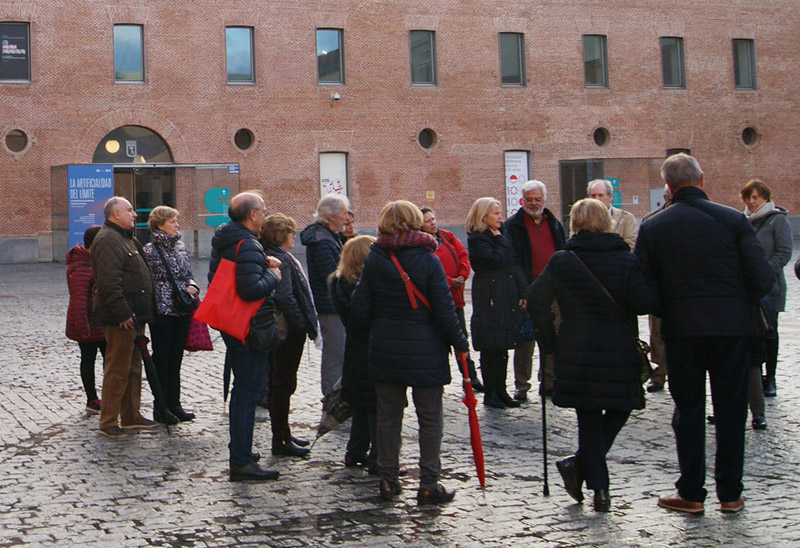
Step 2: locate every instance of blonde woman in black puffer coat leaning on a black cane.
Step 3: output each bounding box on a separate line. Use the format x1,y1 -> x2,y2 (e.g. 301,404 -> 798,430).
527,198 -> 658,511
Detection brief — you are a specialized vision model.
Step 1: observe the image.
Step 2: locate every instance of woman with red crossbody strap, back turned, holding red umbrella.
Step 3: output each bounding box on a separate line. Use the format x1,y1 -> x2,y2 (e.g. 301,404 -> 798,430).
351,200 -> 469,504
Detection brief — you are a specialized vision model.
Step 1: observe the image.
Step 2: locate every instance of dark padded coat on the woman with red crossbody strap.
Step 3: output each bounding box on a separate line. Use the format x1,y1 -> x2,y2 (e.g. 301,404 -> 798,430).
351,243 -> 469,387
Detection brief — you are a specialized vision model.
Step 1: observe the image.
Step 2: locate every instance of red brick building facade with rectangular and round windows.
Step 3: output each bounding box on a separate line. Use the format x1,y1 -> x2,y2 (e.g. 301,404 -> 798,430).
0,0 -> 800,260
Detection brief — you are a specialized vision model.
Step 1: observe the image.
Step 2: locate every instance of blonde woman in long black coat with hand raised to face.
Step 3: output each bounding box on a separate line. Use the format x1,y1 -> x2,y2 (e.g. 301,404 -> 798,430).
466,196 -> 525,409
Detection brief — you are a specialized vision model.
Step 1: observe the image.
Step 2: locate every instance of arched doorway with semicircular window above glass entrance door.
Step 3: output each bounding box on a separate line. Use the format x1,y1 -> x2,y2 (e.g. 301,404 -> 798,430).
92,126 -> 175,243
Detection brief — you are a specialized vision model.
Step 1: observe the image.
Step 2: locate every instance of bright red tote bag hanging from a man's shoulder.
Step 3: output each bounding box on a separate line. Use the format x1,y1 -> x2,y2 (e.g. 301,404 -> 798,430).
194,240 -> 264,344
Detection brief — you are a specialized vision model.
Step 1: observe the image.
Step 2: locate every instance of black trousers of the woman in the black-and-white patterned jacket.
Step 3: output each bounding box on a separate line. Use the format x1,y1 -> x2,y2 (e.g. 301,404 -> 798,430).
150,316 -> 189,409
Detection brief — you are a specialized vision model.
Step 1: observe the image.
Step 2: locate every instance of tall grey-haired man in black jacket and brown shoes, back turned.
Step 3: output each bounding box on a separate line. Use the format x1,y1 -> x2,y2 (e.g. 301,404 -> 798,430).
635,154 -> 773,513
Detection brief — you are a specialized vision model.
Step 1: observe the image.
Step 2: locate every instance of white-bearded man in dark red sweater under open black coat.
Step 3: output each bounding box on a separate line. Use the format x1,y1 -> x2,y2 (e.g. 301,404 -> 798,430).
503,181 -> 566,401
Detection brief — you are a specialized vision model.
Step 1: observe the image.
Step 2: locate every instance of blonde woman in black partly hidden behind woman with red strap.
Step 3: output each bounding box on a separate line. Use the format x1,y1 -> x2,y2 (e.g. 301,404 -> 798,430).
328,236 -> 378,475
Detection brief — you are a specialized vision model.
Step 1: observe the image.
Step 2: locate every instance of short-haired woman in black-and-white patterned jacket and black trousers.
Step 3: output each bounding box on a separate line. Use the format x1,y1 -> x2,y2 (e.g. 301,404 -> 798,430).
144,206 -> 200,424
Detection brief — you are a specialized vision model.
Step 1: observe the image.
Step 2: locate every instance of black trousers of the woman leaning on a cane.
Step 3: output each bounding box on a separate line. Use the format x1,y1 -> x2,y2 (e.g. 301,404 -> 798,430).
575,409 -> 631,490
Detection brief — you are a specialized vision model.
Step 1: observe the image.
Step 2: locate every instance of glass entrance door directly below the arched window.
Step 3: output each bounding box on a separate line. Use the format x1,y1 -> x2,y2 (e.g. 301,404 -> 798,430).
114,167 -> 175,244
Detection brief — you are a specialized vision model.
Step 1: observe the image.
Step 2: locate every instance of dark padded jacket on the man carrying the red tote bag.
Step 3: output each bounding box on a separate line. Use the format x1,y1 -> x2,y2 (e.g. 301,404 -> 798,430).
208,221 -> 278,342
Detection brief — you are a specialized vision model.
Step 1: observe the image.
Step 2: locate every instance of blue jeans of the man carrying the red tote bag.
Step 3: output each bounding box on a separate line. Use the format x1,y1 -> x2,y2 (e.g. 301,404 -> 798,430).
222,333 -> 269,466
